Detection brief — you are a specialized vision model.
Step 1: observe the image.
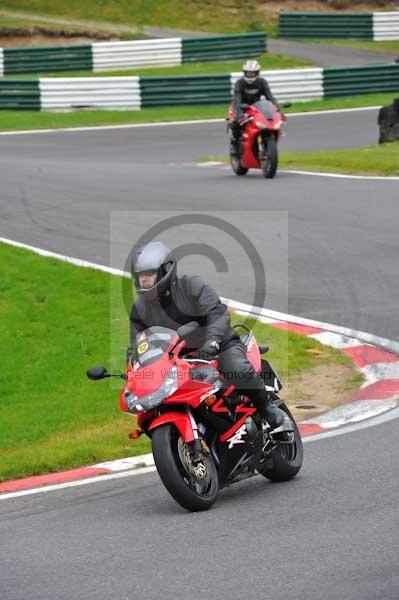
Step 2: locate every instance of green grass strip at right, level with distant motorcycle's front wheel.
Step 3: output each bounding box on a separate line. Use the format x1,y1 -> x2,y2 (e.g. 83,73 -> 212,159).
202,142 -> 399,177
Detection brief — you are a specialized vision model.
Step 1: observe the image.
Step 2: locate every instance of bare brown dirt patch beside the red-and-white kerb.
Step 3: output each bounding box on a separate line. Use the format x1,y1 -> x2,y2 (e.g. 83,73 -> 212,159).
281,363 -> 360,421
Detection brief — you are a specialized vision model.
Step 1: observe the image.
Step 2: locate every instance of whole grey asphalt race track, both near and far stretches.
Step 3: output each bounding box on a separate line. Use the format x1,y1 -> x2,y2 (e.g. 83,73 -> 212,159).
0,110 -> 399,600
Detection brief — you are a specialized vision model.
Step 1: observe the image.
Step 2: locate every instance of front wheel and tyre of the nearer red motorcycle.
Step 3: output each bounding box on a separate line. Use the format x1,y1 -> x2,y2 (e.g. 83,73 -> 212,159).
151,423 -> 219,511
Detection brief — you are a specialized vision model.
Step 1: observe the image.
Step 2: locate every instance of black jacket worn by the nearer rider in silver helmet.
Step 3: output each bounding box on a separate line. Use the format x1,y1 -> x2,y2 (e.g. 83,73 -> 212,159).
127,275 -> 238,359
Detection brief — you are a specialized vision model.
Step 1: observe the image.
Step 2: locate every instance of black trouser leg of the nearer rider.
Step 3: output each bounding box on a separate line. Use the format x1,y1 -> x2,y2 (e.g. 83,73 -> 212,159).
218,340 -> 270,416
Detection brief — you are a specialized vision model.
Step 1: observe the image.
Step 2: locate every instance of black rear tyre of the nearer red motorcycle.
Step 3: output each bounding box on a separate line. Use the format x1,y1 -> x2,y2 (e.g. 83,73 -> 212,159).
259,404 -> 303,481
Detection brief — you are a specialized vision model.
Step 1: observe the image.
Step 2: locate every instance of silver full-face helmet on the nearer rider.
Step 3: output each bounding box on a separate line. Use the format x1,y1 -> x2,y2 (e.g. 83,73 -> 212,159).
131,242 -> 177,300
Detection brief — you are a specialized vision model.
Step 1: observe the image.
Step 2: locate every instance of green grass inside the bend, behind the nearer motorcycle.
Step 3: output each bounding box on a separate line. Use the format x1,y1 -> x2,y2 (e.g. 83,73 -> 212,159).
0,244 -> 350,481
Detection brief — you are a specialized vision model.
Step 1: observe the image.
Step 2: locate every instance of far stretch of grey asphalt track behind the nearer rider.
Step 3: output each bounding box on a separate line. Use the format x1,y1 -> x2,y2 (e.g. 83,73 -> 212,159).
0,110 -> 399,339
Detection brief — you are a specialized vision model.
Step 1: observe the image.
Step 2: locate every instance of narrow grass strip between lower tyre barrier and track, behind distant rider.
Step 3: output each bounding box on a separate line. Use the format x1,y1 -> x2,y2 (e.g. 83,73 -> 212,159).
0,94 -> 395,131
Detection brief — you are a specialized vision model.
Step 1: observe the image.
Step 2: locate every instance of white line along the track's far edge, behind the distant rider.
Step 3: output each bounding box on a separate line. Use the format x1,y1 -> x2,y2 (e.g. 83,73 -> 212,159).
0,106 -> 381,135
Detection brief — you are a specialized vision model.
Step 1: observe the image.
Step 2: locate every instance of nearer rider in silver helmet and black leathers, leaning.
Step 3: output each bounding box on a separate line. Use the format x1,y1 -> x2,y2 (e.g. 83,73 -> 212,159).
127,242 -> 286,429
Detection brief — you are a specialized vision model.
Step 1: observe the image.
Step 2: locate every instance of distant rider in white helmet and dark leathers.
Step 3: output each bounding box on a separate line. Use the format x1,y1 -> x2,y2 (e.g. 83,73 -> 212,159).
230,60 -> 281,156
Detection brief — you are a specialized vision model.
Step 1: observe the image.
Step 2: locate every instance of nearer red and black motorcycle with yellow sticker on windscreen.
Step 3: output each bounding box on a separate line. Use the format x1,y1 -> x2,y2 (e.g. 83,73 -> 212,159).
87,322 -> 303,511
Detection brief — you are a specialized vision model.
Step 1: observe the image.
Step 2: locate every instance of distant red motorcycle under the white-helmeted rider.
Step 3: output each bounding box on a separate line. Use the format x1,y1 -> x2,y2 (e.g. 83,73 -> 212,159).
227,100 -> 291,179
